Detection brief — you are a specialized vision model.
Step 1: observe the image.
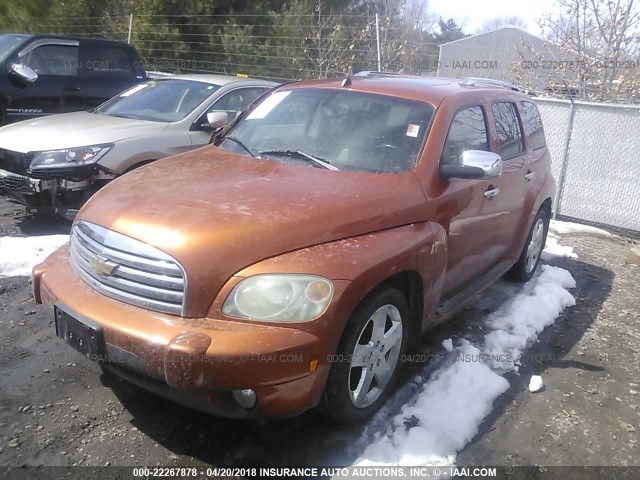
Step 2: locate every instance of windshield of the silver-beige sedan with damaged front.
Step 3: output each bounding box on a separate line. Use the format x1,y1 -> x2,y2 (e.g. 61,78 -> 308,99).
96,79 -> 220,122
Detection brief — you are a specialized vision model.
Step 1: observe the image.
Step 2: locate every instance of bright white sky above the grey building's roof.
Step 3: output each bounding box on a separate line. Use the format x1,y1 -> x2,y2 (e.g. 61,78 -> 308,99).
427,0 -> 551,35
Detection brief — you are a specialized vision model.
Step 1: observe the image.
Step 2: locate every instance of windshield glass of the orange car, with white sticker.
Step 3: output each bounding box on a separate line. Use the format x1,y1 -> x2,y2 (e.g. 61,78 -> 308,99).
220,88 -> 434,173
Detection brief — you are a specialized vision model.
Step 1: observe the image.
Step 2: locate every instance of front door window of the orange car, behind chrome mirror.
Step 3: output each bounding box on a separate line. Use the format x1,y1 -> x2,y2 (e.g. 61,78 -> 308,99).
442,106 -> 489,163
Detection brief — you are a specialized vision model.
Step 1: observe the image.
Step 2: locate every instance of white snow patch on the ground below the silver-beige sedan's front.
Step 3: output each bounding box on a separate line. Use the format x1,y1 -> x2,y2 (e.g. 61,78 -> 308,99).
0,235 -> 69,278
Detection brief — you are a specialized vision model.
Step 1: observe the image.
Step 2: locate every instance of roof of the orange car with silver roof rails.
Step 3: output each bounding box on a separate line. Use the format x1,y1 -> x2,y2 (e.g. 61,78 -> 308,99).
286,72 -> 525,105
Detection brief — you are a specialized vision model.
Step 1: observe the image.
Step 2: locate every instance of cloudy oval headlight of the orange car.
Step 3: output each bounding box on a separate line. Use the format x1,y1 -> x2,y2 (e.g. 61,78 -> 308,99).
222,274 -> 333,322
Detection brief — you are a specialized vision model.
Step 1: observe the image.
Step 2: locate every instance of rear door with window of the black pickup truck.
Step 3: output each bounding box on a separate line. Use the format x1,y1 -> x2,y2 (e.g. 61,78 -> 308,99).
78,40 -> 144,110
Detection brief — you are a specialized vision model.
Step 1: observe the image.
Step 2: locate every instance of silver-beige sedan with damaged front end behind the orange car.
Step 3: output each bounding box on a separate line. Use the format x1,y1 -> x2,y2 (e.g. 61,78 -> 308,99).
0,74 -> 276,219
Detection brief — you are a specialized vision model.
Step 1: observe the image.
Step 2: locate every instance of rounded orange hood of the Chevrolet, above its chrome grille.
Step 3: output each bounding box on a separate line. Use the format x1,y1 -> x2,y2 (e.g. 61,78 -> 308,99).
77,146 -> 426,316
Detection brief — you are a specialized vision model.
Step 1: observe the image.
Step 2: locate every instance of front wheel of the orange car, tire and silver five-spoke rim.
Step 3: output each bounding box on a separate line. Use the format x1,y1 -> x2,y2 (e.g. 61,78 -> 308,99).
321,286 -> 409,425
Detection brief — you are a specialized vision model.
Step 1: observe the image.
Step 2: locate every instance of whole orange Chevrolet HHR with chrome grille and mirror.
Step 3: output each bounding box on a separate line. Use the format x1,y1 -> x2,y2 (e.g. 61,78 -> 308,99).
33,72 -> 555,423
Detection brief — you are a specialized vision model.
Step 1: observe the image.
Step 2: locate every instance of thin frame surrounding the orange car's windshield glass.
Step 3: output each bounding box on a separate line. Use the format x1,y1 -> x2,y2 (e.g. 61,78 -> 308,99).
218,87 -> 439,175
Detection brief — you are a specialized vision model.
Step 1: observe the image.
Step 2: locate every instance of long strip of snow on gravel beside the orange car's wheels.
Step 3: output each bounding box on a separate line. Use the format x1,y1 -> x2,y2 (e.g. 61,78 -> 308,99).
355,265 -> 576,466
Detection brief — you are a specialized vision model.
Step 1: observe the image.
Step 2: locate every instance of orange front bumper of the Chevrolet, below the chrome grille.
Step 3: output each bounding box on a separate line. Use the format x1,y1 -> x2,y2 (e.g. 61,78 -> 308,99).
33,246 -> 328,418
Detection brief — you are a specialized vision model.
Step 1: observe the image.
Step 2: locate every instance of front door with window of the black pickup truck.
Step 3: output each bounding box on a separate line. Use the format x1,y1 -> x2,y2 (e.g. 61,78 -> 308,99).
6,38 -> 84,122
